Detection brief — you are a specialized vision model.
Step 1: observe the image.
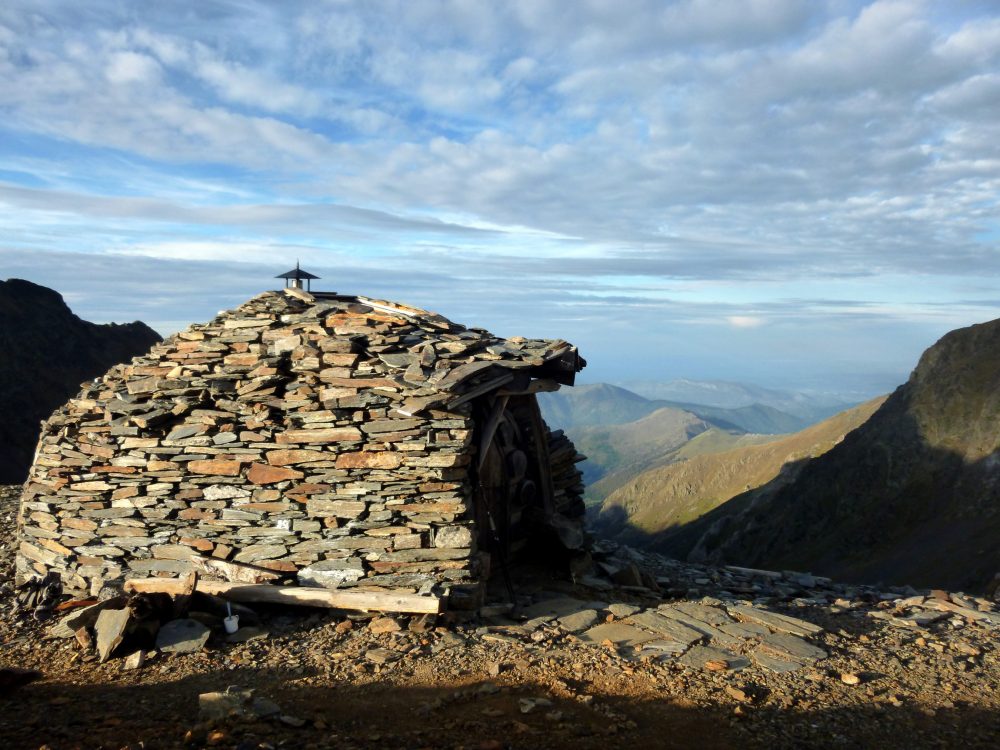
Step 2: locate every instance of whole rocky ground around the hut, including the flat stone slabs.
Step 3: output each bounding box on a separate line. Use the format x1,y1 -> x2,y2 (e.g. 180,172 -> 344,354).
0,488 -> 1000,750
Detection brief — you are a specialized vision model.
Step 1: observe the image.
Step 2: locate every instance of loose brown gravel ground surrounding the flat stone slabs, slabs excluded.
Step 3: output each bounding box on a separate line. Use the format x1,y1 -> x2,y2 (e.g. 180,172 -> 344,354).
0,487 -> 1000,750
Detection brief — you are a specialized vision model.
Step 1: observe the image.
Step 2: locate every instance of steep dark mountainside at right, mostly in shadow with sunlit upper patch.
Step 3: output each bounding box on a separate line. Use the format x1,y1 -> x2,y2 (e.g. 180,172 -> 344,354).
695,320 -> 1000,589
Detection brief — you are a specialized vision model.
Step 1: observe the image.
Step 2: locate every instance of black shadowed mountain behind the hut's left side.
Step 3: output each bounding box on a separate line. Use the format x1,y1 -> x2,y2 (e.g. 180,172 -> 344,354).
0,279 -> 160,484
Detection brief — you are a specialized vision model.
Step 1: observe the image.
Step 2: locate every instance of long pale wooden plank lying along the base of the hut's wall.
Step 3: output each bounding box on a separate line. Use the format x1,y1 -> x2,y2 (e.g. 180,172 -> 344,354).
125,578 -> 442,615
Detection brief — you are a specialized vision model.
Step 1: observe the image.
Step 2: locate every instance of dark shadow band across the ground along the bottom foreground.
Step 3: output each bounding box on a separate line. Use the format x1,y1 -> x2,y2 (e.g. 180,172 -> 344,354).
0,661 -> 1000,750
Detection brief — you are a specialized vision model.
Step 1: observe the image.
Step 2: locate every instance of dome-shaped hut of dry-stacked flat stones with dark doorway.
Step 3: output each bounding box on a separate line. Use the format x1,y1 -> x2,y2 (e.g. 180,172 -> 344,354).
18,288 -> 585,606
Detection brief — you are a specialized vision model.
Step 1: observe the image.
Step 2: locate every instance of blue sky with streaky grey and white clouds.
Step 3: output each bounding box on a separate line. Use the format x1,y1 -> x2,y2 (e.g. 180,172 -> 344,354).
0,0 -> 1000,396
